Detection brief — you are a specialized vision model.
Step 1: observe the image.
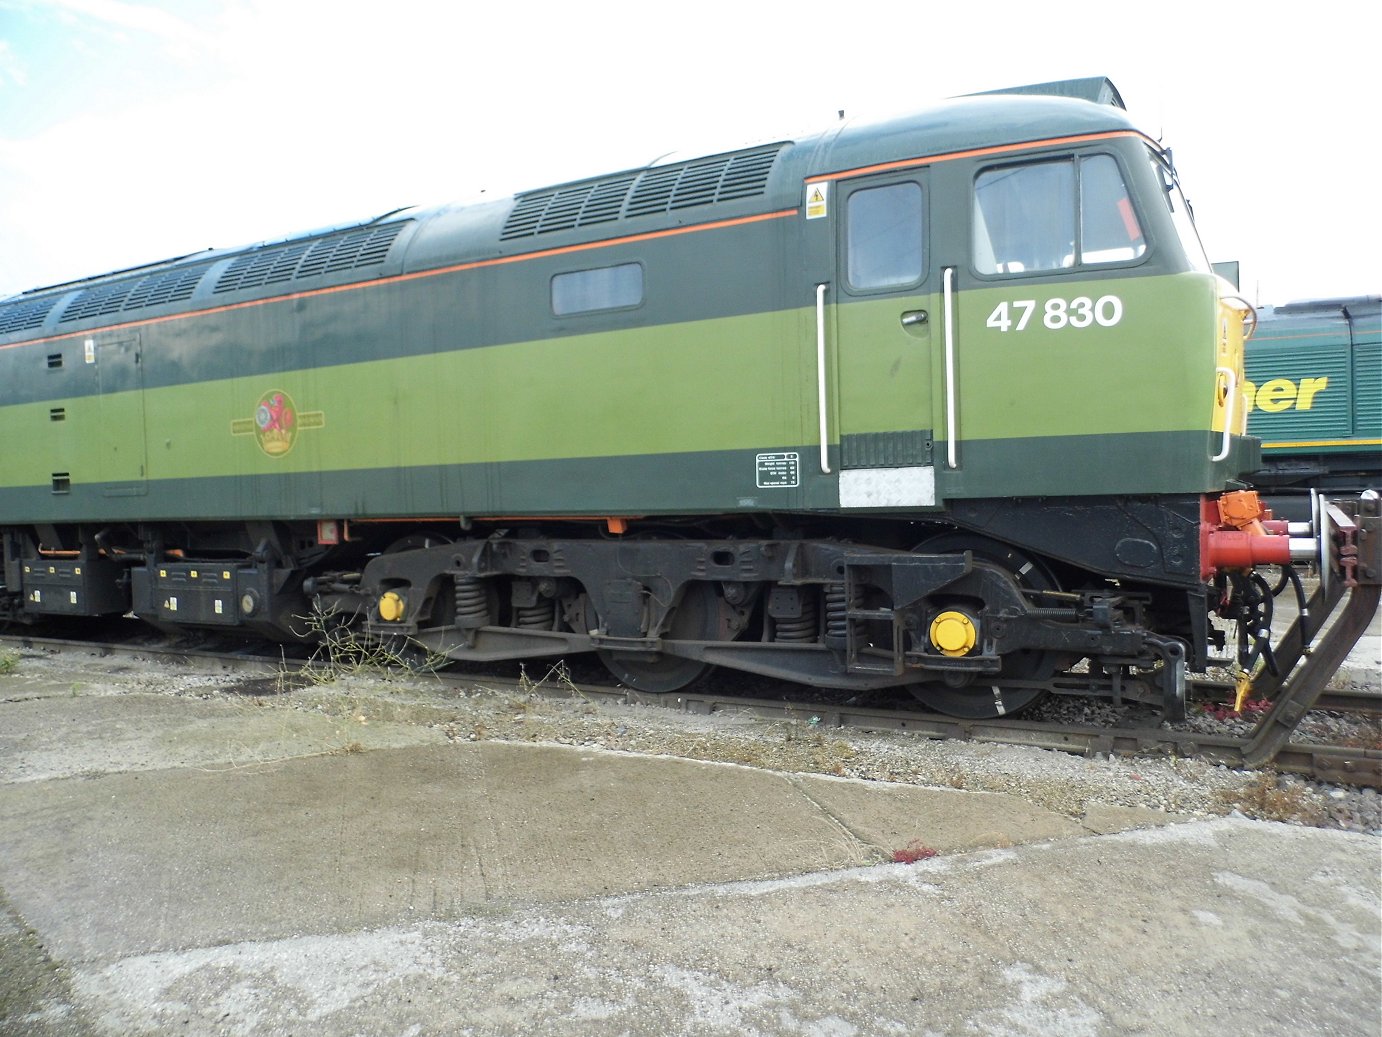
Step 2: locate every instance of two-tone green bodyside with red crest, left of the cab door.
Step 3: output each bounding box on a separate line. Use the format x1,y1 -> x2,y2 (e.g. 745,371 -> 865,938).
0,215 -> 810,521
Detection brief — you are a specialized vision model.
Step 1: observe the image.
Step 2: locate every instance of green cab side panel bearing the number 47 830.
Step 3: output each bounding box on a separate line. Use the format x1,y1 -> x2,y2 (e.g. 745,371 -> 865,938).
938,274 -> 1251,498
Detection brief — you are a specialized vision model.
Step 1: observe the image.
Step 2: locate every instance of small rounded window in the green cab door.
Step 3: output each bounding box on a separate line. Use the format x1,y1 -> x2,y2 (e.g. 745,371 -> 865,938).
844,181 -> 926,290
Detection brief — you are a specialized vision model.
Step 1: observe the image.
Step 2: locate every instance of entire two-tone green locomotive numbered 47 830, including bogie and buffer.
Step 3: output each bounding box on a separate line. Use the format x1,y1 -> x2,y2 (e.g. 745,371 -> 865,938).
0,80 -> 1317,716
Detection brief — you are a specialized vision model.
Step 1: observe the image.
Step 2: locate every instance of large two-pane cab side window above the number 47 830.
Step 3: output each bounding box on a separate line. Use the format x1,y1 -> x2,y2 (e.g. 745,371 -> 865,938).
973,155 -> 1147,274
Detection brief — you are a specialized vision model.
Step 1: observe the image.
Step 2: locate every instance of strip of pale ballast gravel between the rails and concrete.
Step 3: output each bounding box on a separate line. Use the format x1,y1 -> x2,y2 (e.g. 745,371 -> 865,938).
5,651 -> 1382,837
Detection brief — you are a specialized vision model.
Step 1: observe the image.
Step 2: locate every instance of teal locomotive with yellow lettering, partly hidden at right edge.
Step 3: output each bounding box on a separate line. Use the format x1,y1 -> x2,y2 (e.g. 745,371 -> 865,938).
1247,296 -> 1382,495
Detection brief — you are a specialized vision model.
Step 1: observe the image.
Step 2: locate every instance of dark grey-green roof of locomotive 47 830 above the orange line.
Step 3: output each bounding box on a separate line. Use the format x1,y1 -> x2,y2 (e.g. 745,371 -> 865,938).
0,80 -> 1136,336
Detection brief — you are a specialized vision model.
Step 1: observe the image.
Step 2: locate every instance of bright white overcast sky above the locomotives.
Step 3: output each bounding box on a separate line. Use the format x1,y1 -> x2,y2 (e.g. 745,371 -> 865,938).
0,0 -> 1382,303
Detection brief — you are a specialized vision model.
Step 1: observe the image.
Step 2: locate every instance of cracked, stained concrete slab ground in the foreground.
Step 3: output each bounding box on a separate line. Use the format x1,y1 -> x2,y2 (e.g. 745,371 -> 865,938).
0,660 -> 1382,1037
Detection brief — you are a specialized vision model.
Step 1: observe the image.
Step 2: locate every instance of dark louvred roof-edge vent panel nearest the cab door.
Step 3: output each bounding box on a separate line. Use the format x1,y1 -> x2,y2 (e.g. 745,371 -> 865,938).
499,144 -> 785,241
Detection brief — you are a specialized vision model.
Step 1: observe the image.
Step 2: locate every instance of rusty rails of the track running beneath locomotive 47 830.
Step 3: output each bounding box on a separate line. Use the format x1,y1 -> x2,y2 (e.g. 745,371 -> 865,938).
0,636 -> 1382,788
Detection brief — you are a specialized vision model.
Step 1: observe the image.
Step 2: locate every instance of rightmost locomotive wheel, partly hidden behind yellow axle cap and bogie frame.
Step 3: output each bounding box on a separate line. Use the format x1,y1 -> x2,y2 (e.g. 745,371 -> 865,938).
908,532 -> 1060,720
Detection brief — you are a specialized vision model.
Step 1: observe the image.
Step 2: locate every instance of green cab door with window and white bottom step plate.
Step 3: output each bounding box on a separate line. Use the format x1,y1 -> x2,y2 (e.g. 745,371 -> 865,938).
833,169 -> 940,507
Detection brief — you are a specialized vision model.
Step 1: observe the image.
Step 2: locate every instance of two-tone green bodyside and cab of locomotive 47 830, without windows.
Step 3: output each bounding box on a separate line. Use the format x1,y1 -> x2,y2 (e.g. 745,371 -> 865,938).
0,89 -> 1241,536
